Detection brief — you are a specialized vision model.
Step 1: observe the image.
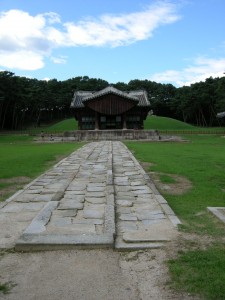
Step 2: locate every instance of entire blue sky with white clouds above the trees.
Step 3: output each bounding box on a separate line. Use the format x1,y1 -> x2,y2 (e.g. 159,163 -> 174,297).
0,0 -> 225,87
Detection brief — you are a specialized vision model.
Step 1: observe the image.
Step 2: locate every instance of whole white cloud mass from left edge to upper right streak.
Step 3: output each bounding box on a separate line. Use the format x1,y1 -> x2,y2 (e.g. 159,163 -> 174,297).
0,2 -> 179,70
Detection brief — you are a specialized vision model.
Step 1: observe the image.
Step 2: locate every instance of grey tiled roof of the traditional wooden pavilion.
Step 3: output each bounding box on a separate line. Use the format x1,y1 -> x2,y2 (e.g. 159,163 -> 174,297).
70,86 -> 150,108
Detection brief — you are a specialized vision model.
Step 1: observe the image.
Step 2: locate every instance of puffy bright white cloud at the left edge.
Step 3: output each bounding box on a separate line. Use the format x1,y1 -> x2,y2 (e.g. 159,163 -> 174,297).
0,10 -> 56,70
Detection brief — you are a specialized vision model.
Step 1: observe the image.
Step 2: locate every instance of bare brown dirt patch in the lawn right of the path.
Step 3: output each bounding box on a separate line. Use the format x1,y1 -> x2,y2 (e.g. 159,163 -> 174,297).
149,172 -> 192,195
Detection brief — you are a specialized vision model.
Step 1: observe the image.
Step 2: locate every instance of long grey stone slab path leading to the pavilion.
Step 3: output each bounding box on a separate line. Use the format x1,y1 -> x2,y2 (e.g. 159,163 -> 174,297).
0,141 -> 180,251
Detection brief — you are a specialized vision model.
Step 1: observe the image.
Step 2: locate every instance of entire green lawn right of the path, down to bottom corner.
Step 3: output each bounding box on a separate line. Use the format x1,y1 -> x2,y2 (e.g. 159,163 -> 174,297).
126,135 -> 225,299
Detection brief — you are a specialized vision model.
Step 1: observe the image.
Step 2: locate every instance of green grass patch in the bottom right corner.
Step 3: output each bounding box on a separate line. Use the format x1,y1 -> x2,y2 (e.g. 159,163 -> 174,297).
168,246 -> 225,300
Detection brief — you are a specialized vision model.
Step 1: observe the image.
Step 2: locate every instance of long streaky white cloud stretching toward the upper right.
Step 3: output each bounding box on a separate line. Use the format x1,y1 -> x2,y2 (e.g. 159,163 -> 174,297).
64,2 -> 179,47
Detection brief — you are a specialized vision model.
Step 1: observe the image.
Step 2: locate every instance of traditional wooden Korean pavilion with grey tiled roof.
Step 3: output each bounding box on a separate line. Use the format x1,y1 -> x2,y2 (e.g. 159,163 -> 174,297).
70,86 -> 150,130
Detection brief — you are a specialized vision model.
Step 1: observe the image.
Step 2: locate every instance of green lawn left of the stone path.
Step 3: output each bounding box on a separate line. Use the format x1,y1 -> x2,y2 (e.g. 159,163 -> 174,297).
0,135 -> 82,201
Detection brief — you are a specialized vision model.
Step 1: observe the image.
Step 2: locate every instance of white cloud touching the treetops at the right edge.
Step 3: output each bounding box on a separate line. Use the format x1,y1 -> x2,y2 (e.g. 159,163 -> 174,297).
149,57 -> 225,87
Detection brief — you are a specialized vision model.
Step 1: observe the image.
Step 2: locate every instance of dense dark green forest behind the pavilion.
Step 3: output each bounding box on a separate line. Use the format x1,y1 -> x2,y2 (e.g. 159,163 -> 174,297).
0,71 -> 225,130
